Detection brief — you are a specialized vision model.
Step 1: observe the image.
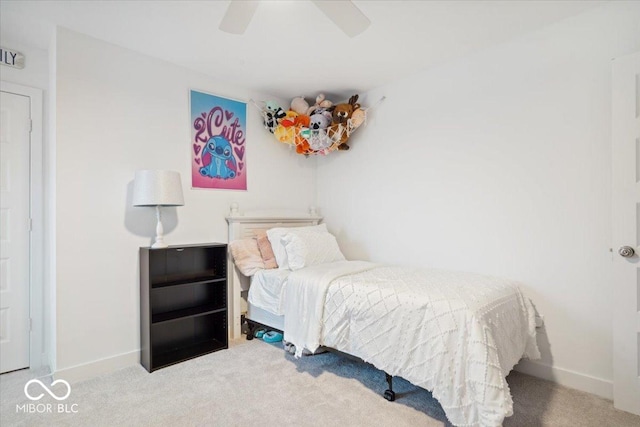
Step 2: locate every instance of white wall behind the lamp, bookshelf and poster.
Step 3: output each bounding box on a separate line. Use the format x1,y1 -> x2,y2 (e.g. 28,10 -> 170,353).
56,29 -> 316,378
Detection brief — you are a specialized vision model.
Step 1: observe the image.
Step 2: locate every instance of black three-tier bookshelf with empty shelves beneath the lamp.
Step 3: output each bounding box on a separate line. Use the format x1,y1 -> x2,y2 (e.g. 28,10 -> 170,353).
140,243 -> 228,372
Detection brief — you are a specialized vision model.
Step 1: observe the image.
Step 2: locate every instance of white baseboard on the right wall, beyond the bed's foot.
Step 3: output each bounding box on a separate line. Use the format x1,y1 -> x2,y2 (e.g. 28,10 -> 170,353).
513,360 -> 613,400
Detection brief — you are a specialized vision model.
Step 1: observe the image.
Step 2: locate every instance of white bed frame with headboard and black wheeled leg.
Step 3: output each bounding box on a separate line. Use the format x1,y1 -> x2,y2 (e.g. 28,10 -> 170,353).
226,203 -> 396,402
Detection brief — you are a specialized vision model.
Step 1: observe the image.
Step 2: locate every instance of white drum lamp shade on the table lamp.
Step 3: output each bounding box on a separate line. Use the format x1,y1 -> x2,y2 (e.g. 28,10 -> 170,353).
133,170 -> 184,206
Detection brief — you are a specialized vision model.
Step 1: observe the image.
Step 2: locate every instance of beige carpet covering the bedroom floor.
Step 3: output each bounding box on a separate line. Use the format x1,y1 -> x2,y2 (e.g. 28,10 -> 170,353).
0,340 -> 640,427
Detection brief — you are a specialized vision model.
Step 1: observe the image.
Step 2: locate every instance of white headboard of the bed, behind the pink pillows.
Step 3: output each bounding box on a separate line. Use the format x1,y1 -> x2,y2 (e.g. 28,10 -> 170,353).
226,204 -> 322,339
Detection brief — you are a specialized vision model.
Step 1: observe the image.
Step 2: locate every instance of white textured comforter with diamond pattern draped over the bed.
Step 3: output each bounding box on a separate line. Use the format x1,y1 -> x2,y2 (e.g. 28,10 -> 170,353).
284,261 -> 540,426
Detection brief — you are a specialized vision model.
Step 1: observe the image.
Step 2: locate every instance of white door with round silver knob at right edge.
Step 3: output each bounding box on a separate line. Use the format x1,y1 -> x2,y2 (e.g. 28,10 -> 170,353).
612,52 -> 640,415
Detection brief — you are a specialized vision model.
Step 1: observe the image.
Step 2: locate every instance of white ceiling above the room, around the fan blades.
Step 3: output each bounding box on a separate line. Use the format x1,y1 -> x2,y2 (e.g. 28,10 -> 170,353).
0,0 -> 603,100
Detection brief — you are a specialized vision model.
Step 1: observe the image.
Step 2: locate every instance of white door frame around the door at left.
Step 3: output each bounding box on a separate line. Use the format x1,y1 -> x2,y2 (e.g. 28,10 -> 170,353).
0,81 -> 47,369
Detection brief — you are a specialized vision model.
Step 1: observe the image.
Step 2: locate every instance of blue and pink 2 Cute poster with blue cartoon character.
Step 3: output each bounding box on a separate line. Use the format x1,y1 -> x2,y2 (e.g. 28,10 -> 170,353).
189,90 -> 247,190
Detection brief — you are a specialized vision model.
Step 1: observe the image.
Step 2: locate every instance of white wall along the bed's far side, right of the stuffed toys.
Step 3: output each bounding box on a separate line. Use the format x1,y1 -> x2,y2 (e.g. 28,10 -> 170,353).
318,2 -> 640,397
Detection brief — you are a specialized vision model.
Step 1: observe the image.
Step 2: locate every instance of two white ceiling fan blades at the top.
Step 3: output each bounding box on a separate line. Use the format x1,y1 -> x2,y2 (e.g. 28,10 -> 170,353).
219,0 -> 371,37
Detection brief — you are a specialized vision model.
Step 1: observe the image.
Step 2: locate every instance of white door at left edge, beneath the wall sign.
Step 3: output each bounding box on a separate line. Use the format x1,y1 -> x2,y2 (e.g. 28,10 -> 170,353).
0,91 -> 31,373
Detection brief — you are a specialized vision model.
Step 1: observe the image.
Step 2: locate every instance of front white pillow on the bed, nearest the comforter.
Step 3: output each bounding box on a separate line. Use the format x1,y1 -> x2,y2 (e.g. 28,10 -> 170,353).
281,231 -> 345,270
